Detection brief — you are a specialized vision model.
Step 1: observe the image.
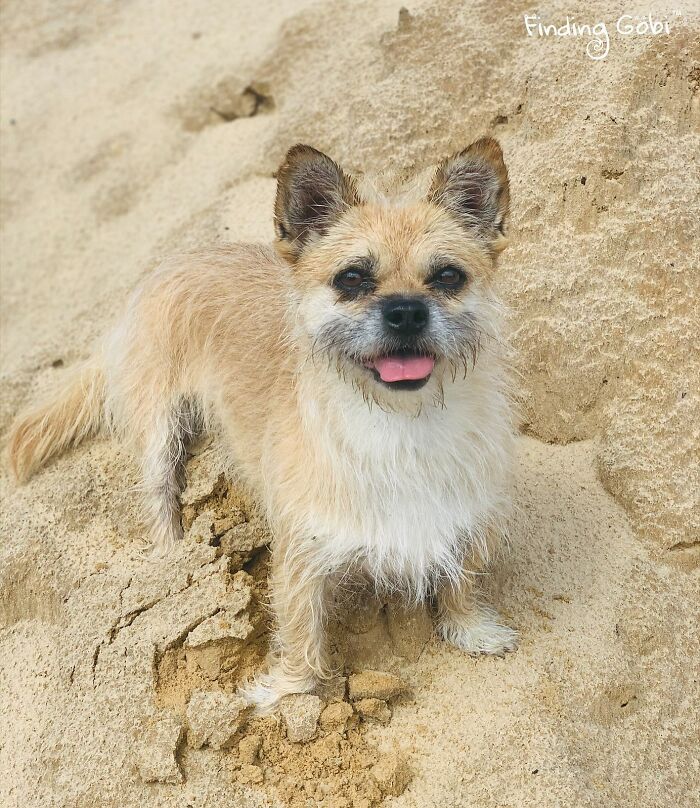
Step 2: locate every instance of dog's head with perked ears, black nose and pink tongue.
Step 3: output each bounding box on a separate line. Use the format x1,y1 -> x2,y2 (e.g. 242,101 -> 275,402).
275,138 -> 509,401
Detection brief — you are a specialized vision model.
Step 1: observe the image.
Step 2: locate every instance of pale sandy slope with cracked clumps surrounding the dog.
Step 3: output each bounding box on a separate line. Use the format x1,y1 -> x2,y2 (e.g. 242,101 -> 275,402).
0,0 -> 700,808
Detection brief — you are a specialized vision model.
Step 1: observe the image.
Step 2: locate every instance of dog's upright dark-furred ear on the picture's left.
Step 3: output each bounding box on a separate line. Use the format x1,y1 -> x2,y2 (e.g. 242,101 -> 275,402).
275,144 -> 359,262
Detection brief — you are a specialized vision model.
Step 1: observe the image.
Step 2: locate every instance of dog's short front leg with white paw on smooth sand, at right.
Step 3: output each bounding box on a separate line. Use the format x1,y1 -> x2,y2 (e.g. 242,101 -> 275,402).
437,569 -> 518,656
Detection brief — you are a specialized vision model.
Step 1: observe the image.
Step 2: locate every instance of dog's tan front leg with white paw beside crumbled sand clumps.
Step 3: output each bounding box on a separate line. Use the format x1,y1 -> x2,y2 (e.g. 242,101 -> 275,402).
244,539 -> 332,711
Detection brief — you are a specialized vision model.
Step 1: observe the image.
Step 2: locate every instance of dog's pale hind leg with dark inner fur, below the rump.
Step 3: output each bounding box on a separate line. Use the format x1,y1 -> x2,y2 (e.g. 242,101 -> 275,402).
141,399 -> 197,555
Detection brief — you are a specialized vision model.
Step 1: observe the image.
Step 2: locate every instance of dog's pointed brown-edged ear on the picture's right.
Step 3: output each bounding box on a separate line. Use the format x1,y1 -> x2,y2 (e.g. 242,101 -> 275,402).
428,137 -> 510,252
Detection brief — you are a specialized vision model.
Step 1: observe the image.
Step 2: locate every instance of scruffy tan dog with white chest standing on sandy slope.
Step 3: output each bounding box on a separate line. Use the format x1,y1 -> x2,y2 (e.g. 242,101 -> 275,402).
10,138 -> 516,707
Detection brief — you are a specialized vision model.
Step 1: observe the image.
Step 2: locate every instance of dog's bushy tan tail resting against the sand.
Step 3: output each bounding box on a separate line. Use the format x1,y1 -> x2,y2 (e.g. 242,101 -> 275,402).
9,360 -> 105,482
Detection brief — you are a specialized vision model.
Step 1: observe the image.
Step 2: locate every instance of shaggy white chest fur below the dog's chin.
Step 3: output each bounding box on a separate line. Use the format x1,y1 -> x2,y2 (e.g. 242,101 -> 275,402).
278,371 -> 513,597
